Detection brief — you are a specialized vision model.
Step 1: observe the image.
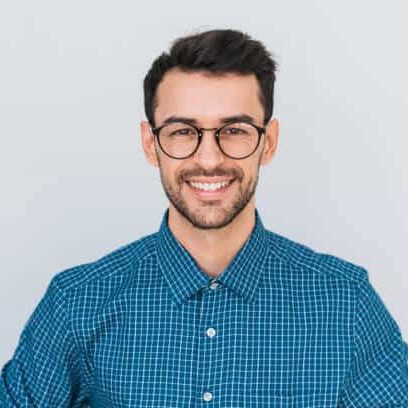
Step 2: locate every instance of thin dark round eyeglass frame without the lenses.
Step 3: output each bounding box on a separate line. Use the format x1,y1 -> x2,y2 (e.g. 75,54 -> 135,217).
151,121 -> 266,160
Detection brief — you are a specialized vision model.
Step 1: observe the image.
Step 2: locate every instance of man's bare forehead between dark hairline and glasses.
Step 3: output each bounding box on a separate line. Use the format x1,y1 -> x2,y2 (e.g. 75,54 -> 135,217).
155,69 -> 263,124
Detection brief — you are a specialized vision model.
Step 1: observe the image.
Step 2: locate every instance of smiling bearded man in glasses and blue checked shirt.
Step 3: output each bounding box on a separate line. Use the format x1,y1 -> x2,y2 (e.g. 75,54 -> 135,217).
0,30 -> 408,408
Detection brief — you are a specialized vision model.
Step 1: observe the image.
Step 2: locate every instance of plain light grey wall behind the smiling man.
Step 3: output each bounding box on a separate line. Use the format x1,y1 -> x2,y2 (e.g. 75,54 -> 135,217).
0,0 -> 408,365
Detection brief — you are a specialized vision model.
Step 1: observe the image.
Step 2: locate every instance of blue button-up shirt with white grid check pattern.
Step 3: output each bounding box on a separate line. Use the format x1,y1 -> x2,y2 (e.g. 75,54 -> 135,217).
0,210 -> 408,408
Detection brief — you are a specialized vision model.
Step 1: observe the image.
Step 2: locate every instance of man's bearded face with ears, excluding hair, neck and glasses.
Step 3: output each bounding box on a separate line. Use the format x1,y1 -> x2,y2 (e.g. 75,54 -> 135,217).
142,69 -> 277,229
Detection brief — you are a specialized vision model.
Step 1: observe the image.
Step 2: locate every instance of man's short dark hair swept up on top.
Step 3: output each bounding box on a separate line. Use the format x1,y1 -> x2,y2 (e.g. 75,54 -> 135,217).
143,29 -> 277,127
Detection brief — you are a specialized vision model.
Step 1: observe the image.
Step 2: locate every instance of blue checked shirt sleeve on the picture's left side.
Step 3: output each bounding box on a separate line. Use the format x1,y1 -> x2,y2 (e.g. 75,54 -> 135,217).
0,279 -> 87,408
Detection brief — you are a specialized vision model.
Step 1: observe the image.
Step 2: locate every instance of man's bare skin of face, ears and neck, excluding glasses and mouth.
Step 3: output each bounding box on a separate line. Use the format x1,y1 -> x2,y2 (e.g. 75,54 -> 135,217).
140,68 -> 279,277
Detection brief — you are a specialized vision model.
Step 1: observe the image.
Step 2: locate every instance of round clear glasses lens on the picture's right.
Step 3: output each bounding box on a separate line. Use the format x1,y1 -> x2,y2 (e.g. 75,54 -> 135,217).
219,123 -> 259,158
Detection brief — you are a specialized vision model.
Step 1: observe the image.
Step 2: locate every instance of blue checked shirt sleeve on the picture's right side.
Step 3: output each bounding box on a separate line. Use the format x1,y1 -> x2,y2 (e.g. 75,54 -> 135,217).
340,275 -> 408,408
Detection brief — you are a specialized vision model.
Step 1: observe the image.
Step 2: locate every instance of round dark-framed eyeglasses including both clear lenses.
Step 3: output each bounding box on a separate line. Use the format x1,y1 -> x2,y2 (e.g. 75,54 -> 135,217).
152,122 -> 265,160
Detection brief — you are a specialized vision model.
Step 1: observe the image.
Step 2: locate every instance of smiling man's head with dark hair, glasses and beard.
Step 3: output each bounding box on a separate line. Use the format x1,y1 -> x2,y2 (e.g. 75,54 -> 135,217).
141,30 -> 278,229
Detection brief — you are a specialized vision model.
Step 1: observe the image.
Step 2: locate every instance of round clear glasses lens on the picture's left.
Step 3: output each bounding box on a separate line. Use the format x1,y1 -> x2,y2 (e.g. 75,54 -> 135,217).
159,123 -> 198,158
